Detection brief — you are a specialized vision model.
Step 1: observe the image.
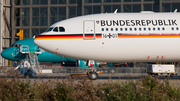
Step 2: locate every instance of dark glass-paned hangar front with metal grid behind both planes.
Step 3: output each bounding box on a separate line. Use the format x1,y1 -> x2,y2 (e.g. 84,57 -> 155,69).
0,0 -> 180,66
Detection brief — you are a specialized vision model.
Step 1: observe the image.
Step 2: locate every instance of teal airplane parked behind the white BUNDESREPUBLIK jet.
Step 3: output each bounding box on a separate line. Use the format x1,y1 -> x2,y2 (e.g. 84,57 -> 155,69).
1,38 -> 98,69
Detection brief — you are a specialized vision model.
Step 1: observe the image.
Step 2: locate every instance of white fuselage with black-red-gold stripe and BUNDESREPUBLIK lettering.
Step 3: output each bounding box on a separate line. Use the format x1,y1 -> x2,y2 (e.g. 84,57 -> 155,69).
34,13 -> 180,62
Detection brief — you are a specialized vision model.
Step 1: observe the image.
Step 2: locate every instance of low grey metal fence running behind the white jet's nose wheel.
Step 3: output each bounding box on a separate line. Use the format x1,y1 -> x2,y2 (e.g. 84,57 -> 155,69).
0,67 -> 180,75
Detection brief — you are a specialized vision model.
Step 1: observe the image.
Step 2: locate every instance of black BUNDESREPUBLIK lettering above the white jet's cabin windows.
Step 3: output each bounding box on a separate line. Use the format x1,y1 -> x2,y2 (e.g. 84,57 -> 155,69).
101,19 -> 177,26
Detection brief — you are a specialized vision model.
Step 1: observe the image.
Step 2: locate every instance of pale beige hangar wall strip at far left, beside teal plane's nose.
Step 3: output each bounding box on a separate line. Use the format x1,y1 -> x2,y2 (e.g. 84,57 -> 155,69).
0,0 -> 12,66
